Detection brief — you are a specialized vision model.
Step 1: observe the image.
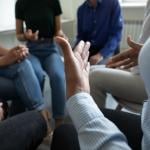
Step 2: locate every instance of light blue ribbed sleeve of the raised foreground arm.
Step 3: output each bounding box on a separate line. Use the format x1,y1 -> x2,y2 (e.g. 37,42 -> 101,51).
67,93 -> 130,150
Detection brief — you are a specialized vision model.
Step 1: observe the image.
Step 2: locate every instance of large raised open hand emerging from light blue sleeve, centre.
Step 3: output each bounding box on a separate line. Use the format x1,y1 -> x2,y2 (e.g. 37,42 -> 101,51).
55,37 -> 90,97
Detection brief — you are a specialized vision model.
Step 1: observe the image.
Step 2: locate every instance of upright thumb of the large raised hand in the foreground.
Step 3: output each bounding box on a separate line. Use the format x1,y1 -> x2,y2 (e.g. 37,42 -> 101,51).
55,36 -> 74,60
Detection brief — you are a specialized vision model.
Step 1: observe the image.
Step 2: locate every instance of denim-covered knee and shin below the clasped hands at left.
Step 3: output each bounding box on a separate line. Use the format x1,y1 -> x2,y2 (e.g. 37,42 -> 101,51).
15,60 -> 45,110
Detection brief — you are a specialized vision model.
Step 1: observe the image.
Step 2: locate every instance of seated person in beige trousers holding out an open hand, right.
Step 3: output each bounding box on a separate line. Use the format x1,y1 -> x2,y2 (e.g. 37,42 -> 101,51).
90,0 -> 150,109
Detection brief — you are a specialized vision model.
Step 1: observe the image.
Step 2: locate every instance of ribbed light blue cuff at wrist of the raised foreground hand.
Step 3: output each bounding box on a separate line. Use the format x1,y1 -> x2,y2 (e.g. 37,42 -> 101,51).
66,92 -> 104,129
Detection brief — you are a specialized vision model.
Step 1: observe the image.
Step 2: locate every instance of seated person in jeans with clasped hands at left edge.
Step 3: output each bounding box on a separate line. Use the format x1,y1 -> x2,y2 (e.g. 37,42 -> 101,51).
0,45 -> 51,132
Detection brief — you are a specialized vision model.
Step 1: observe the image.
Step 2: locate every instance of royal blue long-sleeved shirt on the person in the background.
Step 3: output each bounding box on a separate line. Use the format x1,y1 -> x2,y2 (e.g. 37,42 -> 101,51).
77,0 -> 123,57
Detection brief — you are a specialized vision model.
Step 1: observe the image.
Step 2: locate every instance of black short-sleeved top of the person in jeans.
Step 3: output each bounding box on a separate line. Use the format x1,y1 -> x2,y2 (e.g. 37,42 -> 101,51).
15,0 -> 62,38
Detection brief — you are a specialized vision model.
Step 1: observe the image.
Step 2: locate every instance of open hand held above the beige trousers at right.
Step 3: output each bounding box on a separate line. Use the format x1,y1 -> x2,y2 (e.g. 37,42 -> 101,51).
106,37 -> 143,69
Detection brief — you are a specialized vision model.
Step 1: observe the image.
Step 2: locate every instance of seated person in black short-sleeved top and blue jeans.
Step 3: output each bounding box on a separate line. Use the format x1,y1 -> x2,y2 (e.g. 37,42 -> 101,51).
15,0 -> 66,127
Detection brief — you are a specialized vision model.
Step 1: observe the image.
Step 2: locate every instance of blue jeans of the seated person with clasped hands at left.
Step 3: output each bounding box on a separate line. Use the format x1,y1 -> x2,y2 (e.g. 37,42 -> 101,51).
0,59 -> 45,110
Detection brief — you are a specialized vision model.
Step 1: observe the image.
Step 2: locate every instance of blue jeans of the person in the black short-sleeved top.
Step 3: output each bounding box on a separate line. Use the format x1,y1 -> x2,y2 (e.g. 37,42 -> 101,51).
27,42 -> 66,119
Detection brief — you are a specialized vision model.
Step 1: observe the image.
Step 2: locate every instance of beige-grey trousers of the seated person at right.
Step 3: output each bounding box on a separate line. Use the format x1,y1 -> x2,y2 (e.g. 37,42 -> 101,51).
89,65 -> 147,107
